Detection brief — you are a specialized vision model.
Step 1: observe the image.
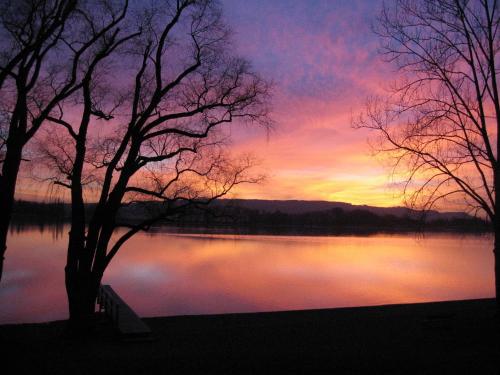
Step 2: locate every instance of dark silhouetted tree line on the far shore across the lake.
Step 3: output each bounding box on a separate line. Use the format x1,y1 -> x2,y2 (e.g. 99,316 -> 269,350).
14,201 -> 491,233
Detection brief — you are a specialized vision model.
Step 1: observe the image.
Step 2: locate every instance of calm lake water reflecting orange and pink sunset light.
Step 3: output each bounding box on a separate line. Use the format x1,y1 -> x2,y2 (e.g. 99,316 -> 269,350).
0,228 -> 494,323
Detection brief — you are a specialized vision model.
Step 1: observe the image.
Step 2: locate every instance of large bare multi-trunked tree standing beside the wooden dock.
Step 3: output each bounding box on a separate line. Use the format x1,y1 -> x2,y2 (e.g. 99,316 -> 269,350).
41,0 -> 269,328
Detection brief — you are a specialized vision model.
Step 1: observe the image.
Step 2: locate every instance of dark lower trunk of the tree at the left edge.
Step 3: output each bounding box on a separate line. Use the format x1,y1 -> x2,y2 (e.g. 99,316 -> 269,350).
0,137 -> 22,281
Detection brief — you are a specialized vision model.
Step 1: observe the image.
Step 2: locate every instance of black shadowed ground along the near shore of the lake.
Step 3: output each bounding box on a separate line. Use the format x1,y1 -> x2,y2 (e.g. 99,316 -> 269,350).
0,300 -> 500,374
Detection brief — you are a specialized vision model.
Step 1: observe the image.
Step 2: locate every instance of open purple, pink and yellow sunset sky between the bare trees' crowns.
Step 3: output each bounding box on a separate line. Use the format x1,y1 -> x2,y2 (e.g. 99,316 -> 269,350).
17,0 -> 401,206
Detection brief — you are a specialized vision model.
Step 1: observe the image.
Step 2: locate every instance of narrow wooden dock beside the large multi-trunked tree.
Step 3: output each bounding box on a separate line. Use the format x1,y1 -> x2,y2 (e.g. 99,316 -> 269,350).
97,285 -> 151,341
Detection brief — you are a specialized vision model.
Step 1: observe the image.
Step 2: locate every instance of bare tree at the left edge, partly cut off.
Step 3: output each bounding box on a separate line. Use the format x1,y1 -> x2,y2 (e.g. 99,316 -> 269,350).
0,0 -> 136,278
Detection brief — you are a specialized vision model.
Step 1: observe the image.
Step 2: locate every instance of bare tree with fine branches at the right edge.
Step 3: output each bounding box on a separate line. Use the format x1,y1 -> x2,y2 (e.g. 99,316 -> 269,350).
355,0 -> 500,302
